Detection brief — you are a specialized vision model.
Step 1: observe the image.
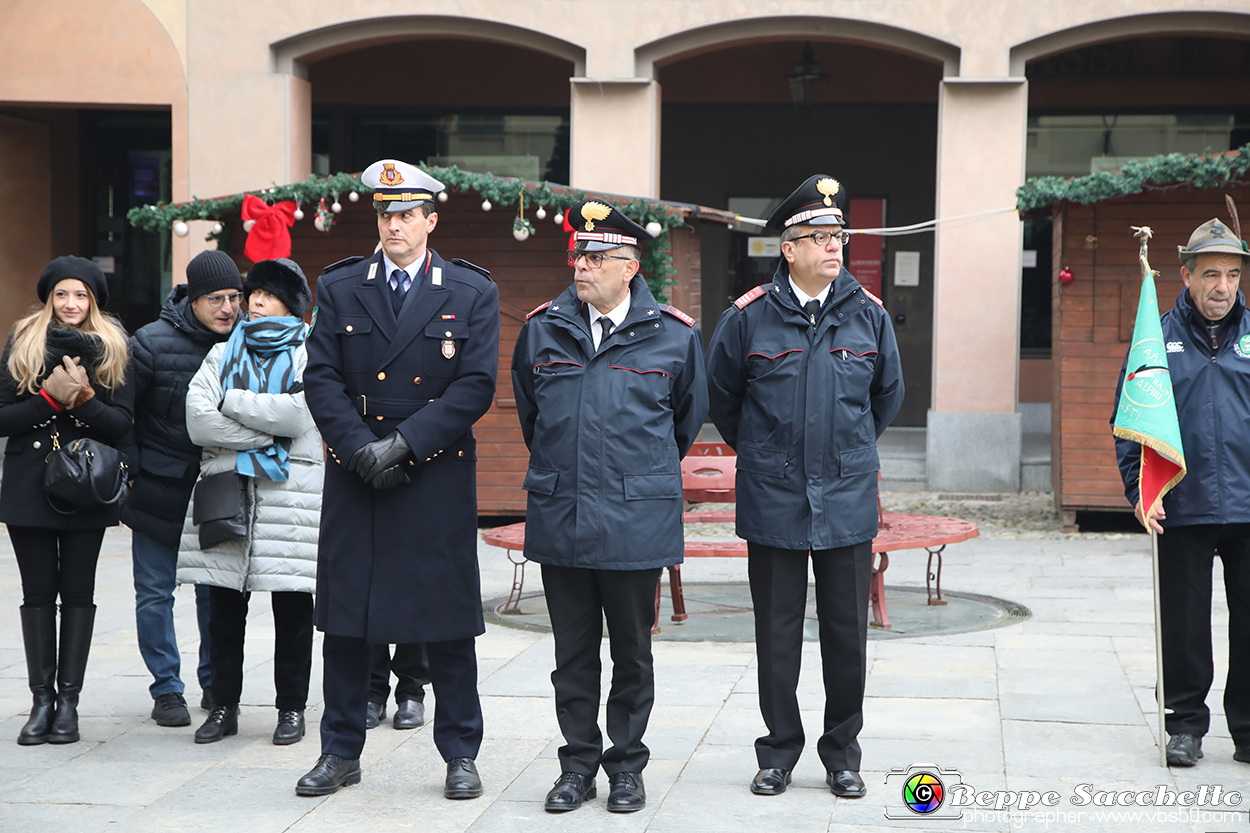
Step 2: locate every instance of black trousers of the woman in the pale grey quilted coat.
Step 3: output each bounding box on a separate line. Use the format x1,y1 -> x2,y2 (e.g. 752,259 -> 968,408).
209,587 -> 313,712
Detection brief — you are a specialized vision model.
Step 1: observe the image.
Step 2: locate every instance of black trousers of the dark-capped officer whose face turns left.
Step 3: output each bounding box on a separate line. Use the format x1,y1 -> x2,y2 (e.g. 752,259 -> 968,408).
543,564 -> 660,777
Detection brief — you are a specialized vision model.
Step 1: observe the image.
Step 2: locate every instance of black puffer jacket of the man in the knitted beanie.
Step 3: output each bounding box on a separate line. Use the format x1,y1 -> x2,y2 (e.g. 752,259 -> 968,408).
121,284 -> 228,549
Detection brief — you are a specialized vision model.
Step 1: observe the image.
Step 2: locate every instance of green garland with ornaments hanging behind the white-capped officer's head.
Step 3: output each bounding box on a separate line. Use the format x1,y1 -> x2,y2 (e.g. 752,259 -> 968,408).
126,165 -> 683,301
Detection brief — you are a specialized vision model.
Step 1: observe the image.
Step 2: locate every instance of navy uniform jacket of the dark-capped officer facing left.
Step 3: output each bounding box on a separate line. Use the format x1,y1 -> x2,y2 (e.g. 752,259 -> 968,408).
513,275 -> 708,570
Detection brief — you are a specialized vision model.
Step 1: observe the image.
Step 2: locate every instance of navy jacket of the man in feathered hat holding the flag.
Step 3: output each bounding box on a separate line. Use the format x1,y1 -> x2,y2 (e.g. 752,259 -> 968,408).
1111,289 -> 1250,528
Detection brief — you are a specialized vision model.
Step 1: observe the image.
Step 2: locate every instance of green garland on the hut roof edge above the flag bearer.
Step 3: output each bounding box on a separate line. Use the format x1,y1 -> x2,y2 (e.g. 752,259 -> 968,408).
1016,144 -> 1250,214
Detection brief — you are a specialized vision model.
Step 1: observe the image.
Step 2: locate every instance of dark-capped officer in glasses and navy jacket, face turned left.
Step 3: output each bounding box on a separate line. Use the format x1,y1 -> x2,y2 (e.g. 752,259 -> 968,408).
513,200 -> 708,813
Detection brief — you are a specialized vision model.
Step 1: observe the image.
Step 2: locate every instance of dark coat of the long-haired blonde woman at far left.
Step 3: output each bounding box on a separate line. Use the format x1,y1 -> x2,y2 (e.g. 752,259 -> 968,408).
0,338 -> 134,529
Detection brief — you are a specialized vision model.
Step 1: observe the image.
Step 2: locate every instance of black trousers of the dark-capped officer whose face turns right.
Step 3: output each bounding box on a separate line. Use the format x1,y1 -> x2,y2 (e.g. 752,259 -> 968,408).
746,542 -> 873,772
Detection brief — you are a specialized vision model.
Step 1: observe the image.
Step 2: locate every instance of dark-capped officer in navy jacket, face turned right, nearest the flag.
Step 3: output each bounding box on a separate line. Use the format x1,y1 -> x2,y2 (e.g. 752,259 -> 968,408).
708,175 -> 903,798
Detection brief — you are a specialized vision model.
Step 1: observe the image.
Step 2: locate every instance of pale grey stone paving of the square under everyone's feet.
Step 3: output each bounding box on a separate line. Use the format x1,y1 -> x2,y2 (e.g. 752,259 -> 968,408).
0,495 -> 1250,833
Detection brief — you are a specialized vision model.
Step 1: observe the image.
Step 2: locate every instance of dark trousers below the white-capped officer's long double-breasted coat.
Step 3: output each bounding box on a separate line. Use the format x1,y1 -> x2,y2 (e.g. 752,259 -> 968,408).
320,633 -> 483,760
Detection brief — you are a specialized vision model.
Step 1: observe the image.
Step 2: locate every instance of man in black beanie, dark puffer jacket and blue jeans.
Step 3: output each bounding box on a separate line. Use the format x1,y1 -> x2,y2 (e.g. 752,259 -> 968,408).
121,250 -> 243,725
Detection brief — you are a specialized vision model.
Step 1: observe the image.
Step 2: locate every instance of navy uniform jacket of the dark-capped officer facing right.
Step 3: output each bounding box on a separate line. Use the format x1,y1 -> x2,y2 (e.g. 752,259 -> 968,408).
708,260 -> 903,550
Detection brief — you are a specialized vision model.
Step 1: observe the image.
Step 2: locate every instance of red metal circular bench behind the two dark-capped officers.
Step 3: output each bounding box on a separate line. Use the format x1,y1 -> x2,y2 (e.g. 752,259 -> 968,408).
483,443 -> 978,629
